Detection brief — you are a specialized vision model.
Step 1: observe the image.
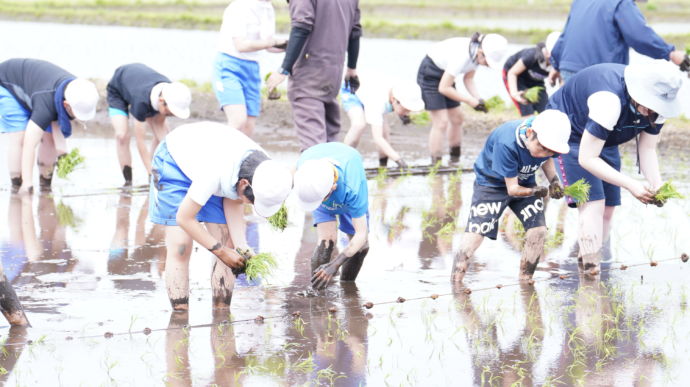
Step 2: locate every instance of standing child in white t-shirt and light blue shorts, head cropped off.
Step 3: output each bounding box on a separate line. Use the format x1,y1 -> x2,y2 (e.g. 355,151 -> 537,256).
213,0 -> 287,137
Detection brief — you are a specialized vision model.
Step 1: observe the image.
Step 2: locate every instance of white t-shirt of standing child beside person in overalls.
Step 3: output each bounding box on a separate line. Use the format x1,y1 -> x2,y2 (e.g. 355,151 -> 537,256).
218,0 -> 276,62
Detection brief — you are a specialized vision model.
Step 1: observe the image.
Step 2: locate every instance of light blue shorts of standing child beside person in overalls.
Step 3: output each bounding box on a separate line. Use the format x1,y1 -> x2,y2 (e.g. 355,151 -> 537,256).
213,53 -> 261,117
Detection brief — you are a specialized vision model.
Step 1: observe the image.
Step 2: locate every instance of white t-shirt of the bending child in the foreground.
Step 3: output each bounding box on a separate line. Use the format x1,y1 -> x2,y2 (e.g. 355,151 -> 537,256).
165,121 -> 265,206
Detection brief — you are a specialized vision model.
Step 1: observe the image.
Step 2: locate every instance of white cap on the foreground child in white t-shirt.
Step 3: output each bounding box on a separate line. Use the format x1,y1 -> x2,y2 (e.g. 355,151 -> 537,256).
252,160 -> 292,218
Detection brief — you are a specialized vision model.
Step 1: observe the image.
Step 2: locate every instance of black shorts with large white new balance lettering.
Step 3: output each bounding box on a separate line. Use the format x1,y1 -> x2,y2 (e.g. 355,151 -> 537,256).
465,183 -> 546,239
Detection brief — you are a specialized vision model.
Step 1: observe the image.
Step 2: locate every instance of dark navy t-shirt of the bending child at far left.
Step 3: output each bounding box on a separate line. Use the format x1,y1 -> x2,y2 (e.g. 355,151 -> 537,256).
0,59 -> 74,130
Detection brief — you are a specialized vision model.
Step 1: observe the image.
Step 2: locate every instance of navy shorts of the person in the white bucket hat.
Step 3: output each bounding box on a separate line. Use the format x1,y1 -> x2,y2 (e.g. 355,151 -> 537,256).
556,144 -> 621,207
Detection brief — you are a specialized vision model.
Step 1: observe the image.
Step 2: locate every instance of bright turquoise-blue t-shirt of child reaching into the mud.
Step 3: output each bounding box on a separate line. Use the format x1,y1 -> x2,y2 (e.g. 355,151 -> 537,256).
297,142 -> 369,218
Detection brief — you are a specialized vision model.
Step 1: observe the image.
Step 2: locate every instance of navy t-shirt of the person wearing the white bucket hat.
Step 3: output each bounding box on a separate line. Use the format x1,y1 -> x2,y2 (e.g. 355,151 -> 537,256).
546,63 -> 662,146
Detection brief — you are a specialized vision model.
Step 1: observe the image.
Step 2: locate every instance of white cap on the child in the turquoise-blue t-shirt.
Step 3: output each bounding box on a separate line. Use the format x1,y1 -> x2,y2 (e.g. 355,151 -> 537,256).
295,159 -> 335,211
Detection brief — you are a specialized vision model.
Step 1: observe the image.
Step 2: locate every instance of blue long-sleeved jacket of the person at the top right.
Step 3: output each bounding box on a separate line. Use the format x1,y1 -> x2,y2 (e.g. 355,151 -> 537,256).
552,0 -> 674,73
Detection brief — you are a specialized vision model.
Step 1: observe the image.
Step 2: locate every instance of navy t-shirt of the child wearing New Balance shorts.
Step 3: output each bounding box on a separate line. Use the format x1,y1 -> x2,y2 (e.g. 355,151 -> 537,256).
474,118 -> 549,188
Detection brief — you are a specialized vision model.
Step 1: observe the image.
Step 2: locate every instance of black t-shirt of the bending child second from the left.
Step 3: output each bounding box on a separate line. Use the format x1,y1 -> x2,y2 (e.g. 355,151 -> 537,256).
108,63 -> 170,121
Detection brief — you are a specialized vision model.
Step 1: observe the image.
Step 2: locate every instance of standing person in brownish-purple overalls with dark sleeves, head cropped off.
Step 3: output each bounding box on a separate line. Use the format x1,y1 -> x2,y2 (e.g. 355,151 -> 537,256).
266,0 -> 362,150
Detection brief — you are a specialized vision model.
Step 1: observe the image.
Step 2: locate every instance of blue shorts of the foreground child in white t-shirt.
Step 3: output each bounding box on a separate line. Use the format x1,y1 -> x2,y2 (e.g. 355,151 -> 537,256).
149,140 -> 227,226
